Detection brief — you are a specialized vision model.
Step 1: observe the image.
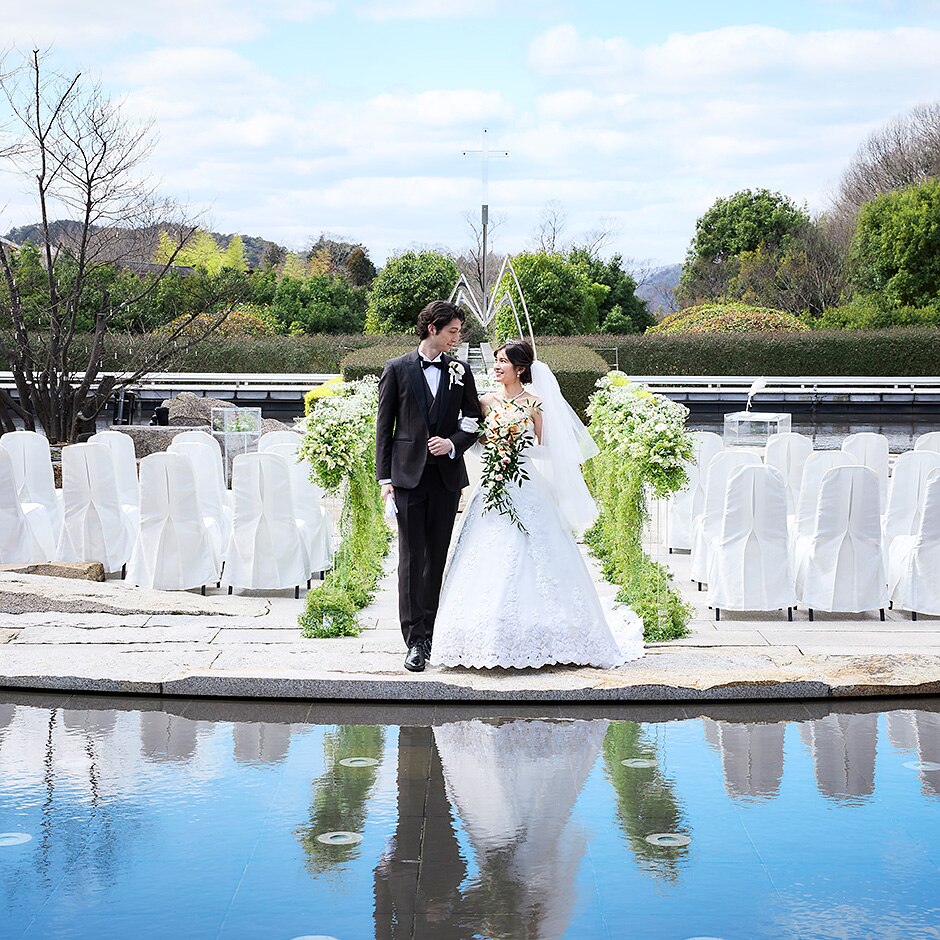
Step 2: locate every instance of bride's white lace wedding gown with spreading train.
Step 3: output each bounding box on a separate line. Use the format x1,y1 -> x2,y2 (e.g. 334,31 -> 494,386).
432,406 -> 643,669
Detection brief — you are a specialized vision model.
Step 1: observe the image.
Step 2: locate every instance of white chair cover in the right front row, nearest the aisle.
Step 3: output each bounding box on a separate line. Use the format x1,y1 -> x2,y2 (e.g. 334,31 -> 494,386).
708,466 -> 796,610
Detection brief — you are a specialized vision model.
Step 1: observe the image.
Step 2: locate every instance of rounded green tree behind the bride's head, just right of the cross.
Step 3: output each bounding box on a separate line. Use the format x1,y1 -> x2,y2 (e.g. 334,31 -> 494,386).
496,252 -> 609,340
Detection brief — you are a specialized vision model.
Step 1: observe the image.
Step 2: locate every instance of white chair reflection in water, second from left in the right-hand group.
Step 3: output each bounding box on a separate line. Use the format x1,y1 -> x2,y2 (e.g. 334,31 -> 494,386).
800,714 -> 878,800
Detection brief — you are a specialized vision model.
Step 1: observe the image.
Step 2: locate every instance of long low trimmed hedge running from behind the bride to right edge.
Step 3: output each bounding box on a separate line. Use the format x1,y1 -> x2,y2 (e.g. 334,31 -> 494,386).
539,327 -> 940,376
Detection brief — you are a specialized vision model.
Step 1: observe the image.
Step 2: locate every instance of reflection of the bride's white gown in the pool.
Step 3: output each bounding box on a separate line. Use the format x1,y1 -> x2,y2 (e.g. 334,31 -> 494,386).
434,720 -> 608,937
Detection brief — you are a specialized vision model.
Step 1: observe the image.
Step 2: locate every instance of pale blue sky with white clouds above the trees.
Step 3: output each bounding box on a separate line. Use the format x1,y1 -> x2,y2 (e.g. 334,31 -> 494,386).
0,0 -> 940,264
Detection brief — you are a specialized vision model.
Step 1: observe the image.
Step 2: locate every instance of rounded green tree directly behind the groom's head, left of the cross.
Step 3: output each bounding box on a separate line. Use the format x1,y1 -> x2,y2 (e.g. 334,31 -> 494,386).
365,251 -> 457,334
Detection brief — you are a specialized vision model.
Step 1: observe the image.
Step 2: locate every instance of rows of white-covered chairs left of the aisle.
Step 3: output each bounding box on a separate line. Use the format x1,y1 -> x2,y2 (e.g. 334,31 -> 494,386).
0,431 -> 332,590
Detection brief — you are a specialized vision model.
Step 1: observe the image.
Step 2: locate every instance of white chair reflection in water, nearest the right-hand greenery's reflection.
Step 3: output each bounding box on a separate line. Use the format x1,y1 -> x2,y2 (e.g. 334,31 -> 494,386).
705,719 -> 786,800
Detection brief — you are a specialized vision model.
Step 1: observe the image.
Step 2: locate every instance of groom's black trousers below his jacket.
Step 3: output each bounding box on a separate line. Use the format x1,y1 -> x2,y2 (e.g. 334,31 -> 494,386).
395,460 -> 460,647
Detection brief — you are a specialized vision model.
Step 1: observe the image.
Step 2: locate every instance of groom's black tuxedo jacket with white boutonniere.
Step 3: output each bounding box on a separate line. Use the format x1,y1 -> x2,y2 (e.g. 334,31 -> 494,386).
375,350 -> 482,491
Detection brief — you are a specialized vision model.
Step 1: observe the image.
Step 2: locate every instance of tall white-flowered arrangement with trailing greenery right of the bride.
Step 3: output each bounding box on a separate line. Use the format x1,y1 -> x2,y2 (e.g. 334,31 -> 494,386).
585,372 -> 693,642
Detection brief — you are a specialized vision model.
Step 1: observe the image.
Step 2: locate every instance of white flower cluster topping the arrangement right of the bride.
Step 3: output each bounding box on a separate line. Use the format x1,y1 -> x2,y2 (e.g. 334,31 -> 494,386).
588,371 -> 693,499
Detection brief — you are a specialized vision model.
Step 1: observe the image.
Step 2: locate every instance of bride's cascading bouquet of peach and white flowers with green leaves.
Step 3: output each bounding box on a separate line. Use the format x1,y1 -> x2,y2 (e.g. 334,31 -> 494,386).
480,401 -> 532,534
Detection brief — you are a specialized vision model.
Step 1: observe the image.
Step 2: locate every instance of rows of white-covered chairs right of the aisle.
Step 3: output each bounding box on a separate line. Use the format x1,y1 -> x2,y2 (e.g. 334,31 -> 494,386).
667,432 -> 940,616
